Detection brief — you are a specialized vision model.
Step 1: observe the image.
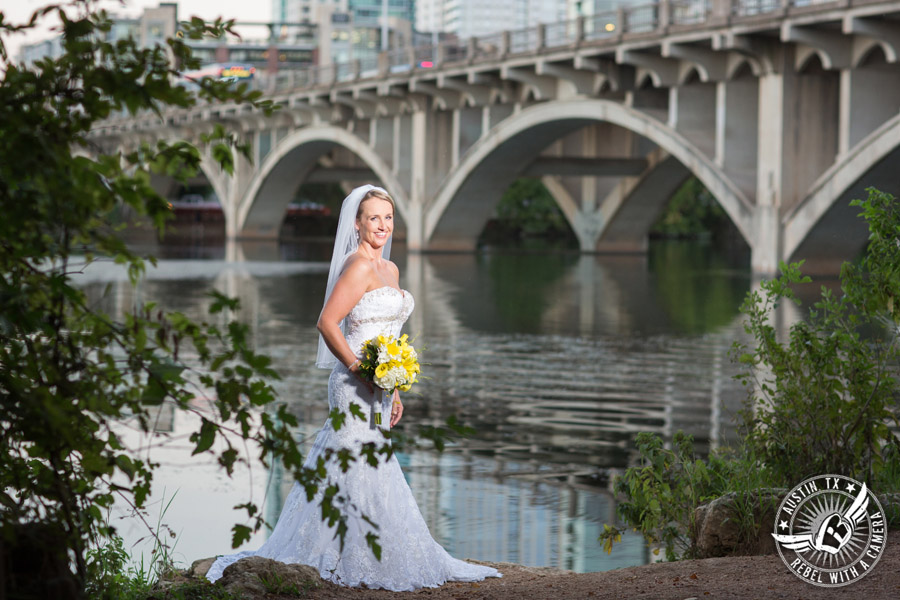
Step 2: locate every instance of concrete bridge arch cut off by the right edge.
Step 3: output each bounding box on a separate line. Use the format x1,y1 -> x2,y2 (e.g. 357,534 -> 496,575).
782,115 -> 900,271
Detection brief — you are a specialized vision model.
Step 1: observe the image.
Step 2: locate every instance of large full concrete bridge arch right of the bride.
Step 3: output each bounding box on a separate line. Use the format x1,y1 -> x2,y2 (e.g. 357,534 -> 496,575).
423,99 -> 754,250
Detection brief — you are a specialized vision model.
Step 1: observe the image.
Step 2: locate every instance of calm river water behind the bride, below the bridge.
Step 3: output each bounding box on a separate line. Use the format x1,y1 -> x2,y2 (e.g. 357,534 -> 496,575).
81,242 -> 751,572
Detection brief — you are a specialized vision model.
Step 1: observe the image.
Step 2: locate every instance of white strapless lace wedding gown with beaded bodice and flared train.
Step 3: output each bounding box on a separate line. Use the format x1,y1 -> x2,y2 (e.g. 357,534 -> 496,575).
206,287 -> 501,591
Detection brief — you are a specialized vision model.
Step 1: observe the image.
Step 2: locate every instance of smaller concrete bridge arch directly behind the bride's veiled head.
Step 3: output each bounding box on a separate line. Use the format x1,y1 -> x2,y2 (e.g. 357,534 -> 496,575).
235,126 -> 409,238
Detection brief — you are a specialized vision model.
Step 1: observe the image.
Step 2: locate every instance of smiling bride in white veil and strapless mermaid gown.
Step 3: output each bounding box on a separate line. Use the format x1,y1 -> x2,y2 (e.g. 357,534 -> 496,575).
206,185 -> 501,591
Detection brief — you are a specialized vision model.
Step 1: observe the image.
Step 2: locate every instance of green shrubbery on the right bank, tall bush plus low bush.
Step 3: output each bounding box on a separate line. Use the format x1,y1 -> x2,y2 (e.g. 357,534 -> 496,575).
600,188 -> 900,560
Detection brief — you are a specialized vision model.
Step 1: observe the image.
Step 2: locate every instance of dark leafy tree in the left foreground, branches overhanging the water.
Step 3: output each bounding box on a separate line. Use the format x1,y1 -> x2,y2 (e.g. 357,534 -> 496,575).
0,0 -> 391,597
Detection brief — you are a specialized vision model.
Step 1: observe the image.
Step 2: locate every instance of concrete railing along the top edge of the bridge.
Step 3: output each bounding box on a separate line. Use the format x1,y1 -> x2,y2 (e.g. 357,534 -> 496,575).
253,0 -> 844,92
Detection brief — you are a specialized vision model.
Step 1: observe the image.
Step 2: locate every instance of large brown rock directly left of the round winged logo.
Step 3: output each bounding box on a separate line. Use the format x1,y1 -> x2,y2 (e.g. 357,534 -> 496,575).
694,489 -> 787,558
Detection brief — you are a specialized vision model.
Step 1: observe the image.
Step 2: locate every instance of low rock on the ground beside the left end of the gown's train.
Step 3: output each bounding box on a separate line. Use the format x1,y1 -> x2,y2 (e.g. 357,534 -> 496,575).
218,556 -> 322,598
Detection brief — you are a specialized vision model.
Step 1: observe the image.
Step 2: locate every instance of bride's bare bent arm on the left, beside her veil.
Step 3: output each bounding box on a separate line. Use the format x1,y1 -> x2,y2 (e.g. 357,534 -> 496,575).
316,260 -> 371,382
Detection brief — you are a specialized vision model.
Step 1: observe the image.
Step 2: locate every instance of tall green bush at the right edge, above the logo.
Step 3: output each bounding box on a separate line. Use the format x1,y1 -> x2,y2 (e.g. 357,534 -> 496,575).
735,188 -> 900,482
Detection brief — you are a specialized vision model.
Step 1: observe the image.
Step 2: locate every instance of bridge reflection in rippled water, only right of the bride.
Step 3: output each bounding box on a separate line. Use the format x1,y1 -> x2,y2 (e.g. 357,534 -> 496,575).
405,255 -> 749,472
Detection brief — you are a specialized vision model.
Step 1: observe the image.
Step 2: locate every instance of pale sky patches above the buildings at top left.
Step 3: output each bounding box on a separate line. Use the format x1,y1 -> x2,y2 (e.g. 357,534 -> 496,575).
0,0 -> 272,57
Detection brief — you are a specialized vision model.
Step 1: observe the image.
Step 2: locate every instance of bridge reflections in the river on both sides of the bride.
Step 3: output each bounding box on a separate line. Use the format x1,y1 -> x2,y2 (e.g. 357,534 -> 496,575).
79,246 -> 749,467
